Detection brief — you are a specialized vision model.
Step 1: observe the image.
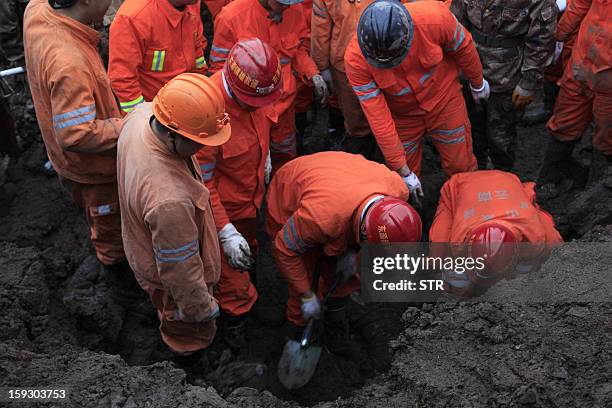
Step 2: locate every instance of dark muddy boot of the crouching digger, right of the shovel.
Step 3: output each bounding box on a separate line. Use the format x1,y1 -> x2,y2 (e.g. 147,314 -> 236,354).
324,297 -> 364,359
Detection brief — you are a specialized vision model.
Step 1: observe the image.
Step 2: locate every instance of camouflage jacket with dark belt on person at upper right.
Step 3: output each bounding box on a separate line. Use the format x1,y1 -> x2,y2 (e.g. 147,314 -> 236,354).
451,0 -> 558,92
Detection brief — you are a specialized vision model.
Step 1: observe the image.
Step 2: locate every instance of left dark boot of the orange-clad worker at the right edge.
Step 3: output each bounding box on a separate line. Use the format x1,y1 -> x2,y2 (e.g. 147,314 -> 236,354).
537,135 -> 576,200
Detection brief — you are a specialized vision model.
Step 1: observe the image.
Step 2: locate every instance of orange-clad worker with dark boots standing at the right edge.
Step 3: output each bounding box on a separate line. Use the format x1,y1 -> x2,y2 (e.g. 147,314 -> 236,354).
538,0 -> 612,190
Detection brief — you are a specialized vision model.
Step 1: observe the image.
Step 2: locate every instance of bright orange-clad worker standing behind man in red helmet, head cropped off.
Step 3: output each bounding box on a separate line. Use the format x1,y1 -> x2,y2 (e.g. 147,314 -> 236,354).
210,0 -> 327,171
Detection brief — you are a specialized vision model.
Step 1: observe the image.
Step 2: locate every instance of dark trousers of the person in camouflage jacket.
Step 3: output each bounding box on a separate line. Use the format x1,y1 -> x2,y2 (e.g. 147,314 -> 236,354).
463,84 -> 519,171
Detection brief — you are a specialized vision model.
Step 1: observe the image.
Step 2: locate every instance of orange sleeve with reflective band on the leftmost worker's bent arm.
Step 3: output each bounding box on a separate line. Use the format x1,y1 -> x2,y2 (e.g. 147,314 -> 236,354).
47,63 -> 123,153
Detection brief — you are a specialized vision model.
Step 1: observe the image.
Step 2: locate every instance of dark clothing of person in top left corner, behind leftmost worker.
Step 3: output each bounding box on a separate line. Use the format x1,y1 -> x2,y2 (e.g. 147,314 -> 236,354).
0,0 -> 28,65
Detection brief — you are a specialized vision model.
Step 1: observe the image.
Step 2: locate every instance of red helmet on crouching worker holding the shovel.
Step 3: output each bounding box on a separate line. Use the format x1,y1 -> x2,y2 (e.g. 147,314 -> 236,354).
356,197 -> 423,243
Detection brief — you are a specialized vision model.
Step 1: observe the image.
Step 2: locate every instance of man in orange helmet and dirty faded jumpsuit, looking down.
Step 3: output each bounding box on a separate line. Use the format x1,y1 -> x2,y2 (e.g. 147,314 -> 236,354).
117,73 -> 231,373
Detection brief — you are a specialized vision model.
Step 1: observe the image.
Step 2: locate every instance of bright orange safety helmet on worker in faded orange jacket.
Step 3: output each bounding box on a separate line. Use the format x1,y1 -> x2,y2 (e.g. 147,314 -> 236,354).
153,73 -> 231,146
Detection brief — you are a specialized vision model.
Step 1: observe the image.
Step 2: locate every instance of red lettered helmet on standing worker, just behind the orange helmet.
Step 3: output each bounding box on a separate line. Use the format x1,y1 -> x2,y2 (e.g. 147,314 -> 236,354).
223,38 -> 283,108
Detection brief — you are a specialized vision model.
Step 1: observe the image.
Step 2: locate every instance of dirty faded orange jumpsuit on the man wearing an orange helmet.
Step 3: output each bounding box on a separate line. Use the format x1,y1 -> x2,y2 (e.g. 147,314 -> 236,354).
117,103 -> 221,353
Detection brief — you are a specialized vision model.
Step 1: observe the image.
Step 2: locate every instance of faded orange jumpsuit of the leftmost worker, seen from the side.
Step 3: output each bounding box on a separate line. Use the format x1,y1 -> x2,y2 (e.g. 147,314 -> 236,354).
24,0 -> 125,265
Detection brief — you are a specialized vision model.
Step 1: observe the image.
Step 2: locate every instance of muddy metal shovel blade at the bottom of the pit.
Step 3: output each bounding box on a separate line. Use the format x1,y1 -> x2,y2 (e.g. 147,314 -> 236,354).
278,340 -> 321,390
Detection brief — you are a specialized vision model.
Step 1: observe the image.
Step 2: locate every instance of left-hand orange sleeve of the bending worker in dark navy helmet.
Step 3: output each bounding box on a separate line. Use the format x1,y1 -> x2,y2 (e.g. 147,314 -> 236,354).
344,44 -> 406,170
